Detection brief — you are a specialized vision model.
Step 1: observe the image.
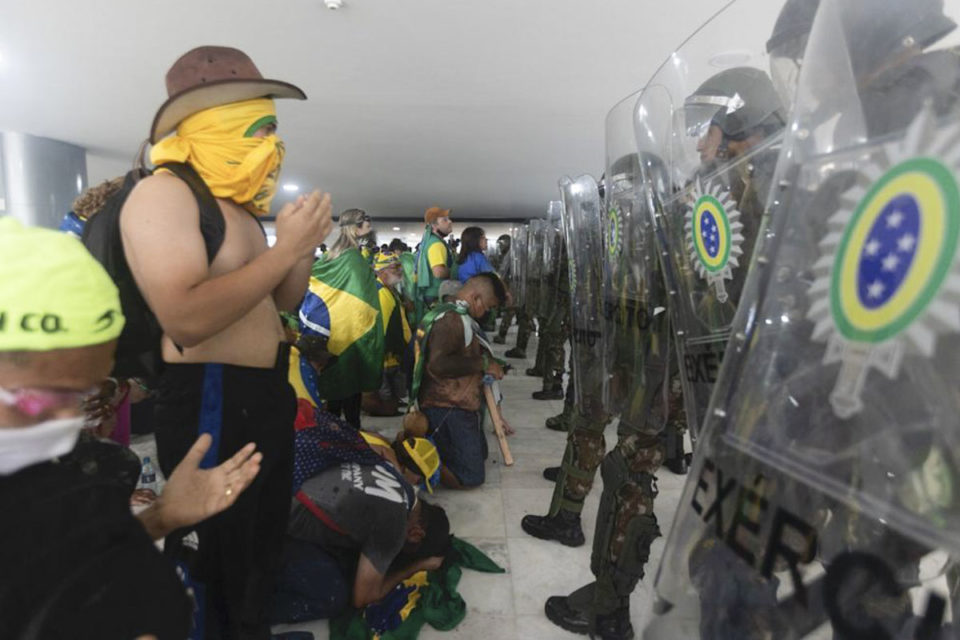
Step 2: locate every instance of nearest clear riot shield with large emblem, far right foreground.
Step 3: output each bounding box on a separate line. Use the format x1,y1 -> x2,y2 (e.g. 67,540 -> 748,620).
645,0 -> 960,639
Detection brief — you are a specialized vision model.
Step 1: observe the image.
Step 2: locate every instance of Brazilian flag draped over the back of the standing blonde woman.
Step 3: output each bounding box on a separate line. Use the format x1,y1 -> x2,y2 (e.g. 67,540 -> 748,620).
300,249 -> 383,400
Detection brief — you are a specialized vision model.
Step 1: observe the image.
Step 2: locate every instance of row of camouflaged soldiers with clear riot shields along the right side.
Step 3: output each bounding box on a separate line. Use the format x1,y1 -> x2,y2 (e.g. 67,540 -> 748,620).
501,0 -> 960,639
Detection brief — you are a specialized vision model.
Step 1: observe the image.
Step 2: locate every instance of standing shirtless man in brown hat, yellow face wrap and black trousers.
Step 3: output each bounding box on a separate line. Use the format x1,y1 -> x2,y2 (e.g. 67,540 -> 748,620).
120,47 -> 332,638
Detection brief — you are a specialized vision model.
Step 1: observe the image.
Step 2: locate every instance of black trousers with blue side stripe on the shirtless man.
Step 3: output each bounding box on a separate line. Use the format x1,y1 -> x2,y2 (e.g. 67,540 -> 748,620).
154,345 -> 296,640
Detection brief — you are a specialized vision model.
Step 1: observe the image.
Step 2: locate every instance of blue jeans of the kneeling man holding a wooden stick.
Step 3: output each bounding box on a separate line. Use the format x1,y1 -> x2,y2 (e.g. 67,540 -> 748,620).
423,407 -> 488,487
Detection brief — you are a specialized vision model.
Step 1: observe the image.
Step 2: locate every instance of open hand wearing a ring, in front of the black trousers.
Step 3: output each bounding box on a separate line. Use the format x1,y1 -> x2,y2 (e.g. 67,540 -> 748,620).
156,433 -> 263,530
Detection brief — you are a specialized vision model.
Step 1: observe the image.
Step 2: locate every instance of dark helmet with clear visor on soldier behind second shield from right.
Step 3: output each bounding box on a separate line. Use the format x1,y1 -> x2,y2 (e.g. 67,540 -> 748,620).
684,67 -> 787,140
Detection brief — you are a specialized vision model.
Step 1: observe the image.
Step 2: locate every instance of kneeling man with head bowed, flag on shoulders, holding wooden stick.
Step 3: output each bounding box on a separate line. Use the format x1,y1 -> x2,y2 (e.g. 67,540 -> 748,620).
411,273 -> 507,489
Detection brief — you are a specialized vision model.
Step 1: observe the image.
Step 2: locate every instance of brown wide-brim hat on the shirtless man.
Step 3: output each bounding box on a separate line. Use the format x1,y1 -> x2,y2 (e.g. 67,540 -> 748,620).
150,46 -> 307,144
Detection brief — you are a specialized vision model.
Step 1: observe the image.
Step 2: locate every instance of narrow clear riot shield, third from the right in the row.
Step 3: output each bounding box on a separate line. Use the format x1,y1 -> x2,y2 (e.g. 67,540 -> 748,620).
602,94 -> 671,429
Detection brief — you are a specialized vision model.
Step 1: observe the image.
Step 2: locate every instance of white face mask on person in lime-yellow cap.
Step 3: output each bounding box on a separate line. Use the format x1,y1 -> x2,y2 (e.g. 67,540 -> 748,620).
0,416 -> 83,476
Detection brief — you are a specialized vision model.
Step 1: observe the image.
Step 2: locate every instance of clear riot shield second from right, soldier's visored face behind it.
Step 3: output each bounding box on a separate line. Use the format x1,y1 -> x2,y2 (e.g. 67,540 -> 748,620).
637,0 -> 786,452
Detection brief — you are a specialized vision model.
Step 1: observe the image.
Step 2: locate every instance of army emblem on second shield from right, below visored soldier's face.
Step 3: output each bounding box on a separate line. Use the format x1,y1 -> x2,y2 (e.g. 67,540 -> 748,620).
686,182 -> 743,302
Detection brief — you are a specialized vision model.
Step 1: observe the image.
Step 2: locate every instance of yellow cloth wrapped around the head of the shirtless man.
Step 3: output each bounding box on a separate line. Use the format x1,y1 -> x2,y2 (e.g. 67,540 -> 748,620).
150,98 -> 284,215
